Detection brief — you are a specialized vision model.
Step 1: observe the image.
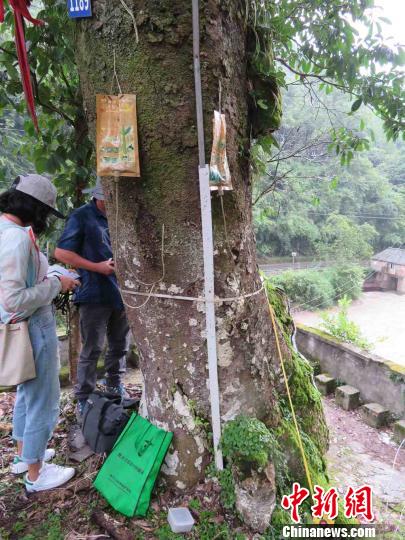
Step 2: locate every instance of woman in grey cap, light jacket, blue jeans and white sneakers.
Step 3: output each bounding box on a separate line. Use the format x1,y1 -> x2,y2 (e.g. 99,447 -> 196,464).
0,174 -> 78,492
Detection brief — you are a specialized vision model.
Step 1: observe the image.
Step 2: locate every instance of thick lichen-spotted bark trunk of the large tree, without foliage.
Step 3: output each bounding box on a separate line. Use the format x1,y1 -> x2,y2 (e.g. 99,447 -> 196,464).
77,0 -> 326,489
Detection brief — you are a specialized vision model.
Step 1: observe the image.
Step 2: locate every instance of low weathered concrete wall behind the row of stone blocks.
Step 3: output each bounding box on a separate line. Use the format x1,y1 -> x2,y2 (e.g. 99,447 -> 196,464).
296,326 -> 405,417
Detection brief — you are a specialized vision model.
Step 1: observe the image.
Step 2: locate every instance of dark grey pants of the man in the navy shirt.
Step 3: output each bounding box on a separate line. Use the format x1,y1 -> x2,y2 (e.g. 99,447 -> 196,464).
75,304 -> 129,399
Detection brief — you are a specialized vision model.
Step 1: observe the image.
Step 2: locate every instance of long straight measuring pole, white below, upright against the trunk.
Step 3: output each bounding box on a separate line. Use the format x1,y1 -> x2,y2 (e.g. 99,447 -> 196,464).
192,0 -> 224,470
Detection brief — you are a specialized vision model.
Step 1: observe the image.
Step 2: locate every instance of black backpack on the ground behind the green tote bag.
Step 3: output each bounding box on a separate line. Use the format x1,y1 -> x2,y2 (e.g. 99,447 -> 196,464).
82,391 -> 139,454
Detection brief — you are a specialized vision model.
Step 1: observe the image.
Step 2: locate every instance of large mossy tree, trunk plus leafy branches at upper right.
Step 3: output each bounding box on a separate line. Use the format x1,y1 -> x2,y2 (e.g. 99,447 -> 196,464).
76,0 -> 403,528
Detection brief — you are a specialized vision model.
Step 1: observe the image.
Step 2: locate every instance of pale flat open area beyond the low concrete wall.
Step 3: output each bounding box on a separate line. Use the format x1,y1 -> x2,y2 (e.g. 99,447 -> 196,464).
294,291 -> 405,366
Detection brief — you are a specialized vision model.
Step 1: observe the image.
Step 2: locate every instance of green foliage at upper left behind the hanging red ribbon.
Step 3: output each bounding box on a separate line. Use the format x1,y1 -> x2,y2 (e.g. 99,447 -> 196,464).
0,0 -> 93,205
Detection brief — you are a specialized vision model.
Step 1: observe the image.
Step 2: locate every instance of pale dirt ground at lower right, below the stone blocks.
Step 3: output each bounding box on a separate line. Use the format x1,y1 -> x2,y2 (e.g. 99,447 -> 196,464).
324,398 -> 405,538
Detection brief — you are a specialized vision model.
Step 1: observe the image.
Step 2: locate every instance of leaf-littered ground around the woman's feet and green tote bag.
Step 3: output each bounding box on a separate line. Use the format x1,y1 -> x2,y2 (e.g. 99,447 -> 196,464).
0,377 -> 247,540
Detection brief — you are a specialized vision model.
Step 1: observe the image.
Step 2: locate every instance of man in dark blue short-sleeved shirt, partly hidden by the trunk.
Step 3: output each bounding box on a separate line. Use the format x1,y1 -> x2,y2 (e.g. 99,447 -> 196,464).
55,178 -> 129,416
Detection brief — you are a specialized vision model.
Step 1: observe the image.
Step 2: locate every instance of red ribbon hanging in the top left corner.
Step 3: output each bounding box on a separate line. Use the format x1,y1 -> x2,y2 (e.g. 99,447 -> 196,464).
0,0 -> 44,131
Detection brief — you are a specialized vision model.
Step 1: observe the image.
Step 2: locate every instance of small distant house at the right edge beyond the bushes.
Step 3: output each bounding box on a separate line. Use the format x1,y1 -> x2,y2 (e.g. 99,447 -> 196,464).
365,248 -> 405,294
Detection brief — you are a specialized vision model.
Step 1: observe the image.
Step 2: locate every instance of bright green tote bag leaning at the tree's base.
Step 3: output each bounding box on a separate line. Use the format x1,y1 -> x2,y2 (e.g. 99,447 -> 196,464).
94,413 -> 173,517
